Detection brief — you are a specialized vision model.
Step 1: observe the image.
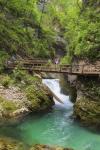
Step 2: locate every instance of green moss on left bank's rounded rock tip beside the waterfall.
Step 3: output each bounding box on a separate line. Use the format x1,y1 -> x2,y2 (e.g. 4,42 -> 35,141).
26,85 -> 53,111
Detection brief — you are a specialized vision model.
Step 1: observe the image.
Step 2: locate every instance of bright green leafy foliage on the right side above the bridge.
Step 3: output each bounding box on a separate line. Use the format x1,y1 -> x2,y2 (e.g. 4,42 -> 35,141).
65,1 -> 100,60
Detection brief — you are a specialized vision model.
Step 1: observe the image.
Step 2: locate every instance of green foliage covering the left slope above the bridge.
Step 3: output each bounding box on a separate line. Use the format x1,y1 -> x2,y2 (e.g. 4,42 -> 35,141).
0,0 -> 65,61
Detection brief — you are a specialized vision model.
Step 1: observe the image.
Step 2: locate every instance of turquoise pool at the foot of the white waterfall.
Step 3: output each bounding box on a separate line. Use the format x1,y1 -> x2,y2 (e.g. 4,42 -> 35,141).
19,109 -> 100,150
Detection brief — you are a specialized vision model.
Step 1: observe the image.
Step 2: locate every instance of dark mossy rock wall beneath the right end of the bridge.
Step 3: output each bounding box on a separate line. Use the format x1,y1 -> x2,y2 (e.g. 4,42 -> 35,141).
69,76 -> 100,129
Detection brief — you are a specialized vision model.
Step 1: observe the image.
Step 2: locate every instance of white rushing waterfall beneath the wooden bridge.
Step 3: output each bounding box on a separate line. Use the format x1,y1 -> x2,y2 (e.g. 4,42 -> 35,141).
42,79 -> 73,109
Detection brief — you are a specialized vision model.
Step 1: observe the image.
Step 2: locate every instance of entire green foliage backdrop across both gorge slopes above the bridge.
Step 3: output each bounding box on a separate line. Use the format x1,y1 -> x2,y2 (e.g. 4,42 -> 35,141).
0,0 -> 100,63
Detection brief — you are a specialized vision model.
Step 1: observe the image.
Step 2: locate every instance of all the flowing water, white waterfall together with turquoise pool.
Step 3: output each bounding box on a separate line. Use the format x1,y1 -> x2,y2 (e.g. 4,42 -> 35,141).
0,80 -> 100,150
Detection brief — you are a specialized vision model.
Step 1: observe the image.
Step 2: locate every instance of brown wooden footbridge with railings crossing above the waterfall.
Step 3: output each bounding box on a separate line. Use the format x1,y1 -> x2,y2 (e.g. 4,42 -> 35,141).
6,59 -> 100,75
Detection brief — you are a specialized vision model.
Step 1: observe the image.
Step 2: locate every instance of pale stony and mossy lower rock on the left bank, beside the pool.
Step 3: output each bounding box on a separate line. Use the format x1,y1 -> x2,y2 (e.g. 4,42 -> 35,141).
0,82 -> 54,121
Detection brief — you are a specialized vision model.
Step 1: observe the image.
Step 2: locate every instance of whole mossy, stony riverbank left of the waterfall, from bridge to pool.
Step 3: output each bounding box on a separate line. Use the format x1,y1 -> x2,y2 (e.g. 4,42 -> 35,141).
0,70 -> 54,122
